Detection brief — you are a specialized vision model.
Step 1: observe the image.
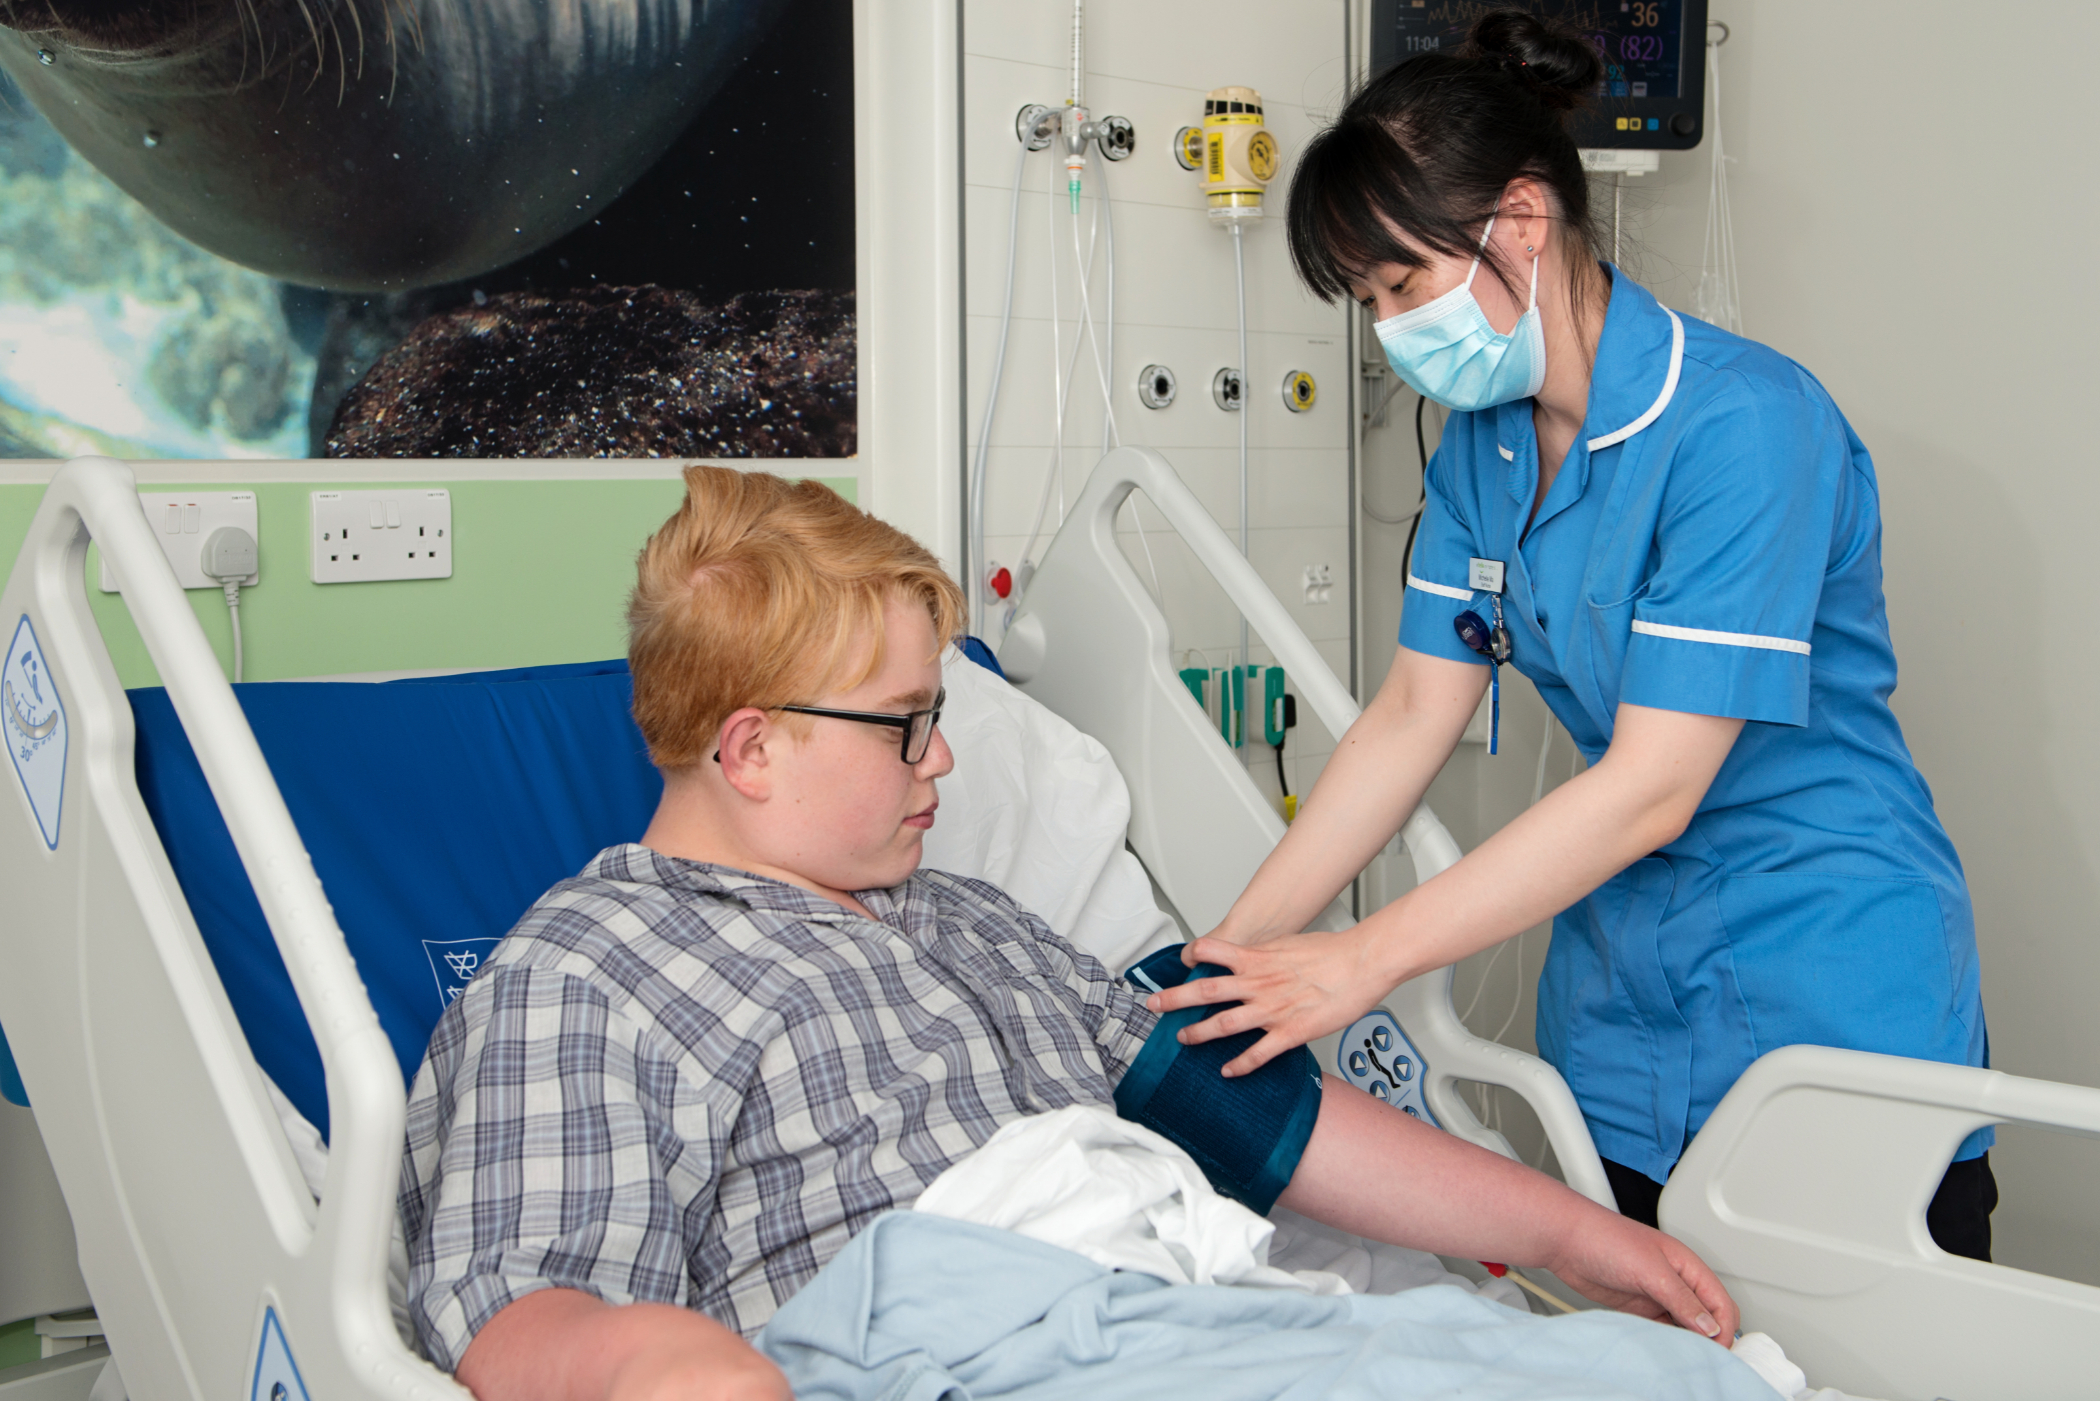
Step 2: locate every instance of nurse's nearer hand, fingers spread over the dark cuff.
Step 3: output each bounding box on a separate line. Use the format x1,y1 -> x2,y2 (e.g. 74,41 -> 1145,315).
1145,930 -> 1399,1075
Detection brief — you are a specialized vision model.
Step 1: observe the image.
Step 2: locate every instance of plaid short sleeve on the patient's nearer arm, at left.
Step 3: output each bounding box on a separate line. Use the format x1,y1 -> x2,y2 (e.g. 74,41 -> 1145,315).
401,966 -> 722,1372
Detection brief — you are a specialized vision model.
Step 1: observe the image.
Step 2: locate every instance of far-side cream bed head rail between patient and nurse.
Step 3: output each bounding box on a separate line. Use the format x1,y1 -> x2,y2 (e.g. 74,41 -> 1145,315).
1000,447 -> 1615,1206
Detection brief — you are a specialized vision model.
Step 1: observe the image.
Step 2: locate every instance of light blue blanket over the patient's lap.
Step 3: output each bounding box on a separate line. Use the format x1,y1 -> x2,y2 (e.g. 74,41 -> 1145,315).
758,1212 -> 1777,1401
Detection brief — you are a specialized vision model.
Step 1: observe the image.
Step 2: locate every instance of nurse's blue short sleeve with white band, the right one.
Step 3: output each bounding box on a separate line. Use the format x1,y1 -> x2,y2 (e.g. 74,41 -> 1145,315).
1619,376 -> 1847,725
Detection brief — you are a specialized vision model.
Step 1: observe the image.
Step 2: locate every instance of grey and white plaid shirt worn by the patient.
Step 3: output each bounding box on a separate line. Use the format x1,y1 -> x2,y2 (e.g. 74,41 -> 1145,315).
401,846 -> 1153,1369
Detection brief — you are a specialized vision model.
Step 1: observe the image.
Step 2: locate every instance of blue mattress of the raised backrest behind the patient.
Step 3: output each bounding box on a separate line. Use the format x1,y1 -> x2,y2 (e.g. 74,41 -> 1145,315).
130,662 -> 664,1136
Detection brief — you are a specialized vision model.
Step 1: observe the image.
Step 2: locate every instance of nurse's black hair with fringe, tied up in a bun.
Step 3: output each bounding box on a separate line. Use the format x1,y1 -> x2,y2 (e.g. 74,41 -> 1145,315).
1287,11 -> 1604,312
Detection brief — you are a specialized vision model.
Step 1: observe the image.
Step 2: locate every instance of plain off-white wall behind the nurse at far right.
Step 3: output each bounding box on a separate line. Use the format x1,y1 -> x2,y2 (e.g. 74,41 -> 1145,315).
1365,0 -> 2100,1283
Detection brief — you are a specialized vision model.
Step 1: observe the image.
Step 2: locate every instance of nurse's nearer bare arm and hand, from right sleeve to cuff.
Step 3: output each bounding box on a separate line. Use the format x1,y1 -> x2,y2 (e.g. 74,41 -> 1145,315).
1147,706 -> 1743,1075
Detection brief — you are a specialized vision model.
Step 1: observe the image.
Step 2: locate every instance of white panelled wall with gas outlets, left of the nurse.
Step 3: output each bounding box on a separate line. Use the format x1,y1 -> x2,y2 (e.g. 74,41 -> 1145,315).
962,0 -> 1350,814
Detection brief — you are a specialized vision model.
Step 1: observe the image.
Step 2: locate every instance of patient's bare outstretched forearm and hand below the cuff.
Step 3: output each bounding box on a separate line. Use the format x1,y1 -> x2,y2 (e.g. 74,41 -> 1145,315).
1277,1075 -> 1737,1344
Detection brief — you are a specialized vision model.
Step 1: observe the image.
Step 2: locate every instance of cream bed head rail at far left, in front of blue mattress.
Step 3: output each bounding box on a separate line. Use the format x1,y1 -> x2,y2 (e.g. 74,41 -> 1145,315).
0,458 -> 466,1401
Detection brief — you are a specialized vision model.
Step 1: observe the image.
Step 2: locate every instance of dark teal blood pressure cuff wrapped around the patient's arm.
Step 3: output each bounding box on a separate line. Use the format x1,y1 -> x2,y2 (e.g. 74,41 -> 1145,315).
1115,945 -> 1321,1216
